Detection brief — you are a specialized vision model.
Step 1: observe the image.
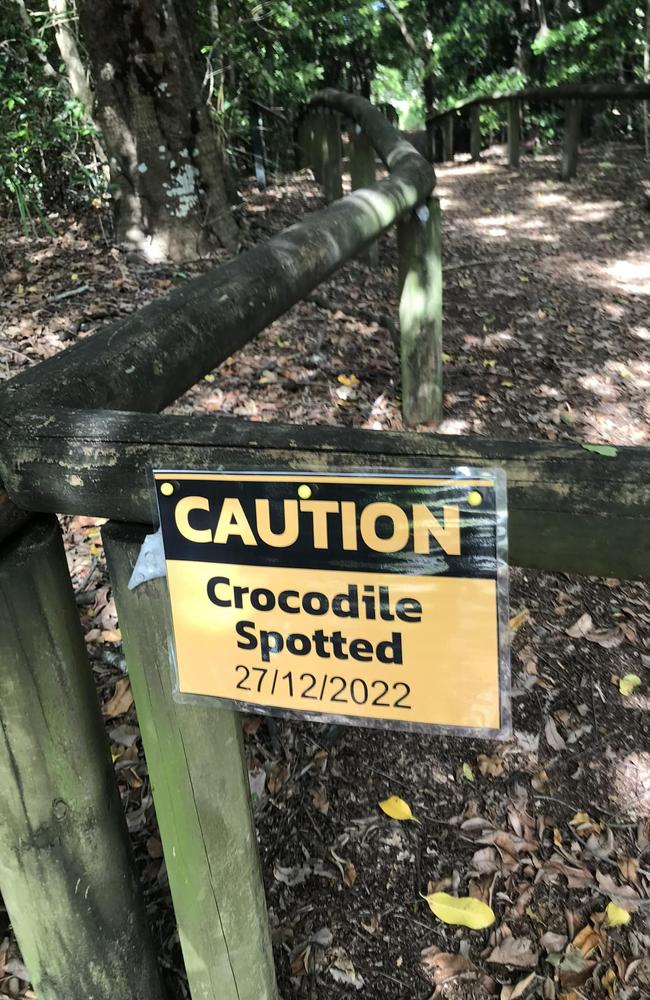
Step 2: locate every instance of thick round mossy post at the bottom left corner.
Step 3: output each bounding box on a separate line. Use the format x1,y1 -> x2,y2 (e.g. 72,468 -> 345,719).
0,516 -> 163,1000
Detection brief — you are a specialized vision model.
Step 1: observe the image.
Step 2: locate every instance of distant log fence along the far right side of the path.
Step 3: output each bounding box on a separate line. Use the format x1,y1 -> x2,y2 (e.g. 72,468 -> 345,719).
427,83 -> 650,181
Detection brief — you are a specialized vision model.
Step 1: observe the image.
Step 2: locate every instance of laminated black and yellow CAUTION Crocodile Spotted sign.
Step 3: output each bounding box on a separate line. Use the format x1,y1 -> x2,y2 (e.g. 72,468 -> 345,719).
154,469 -> 508,735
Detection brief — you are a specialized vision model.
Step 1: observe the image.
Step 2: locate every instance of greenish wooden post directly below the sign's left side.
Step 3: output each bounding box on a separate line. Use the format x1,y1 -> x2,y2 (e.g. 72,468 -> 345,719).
103,524 -> 277,1000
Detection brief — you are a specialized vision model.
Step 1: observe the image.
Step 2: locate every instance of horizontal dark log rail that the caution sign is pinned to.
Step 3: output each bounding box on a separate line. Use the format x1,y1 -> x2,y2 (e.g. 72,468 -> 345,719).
0,410 -> 650,579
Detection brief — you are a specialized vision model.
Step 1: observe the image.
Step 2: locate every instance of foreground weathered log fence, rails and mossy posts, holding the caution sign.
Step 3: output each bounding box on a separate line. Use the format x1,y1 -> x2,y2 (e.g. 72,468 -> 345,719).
0,91 -> 650,1000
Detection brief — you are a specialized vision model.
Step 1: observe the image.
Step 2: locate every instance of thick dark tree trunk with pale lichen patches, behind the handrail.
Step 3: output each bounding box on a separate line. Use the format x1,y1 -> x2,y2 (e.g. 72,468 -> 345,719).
79,0 -> 238,261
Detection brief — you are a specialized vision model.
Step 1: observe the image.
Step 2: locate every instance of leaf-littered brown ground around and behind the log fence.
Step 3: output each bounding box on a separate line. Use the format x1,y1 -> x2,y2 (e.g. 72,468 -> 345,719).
0,148 -> 650,1000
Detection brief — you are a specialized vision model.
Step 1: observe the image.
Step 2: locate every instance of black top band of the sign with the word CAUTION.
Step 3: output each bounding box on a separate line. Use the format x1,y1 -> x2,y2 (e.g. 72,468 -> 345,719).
158,476 -> 497,579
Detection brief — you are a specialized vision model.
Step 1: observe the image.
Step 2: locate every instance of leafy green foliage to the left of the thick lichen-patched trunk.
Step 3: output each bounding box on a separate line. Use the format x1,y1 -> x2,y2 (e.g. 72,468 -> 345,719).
0,3 -> 101,233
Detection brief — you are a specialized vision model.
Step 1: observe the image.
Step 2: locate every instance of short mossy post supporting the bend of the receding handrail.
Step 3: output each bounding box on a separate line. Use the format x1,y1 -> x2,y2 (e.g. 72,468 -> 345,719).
397,198 -> 442,424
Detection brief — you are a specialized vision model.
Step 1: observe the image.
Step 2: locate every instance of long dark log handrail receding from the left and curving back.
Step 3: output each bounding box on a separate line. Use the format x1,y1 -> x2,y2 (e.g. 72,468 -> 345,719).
0,90 -> 435,412
